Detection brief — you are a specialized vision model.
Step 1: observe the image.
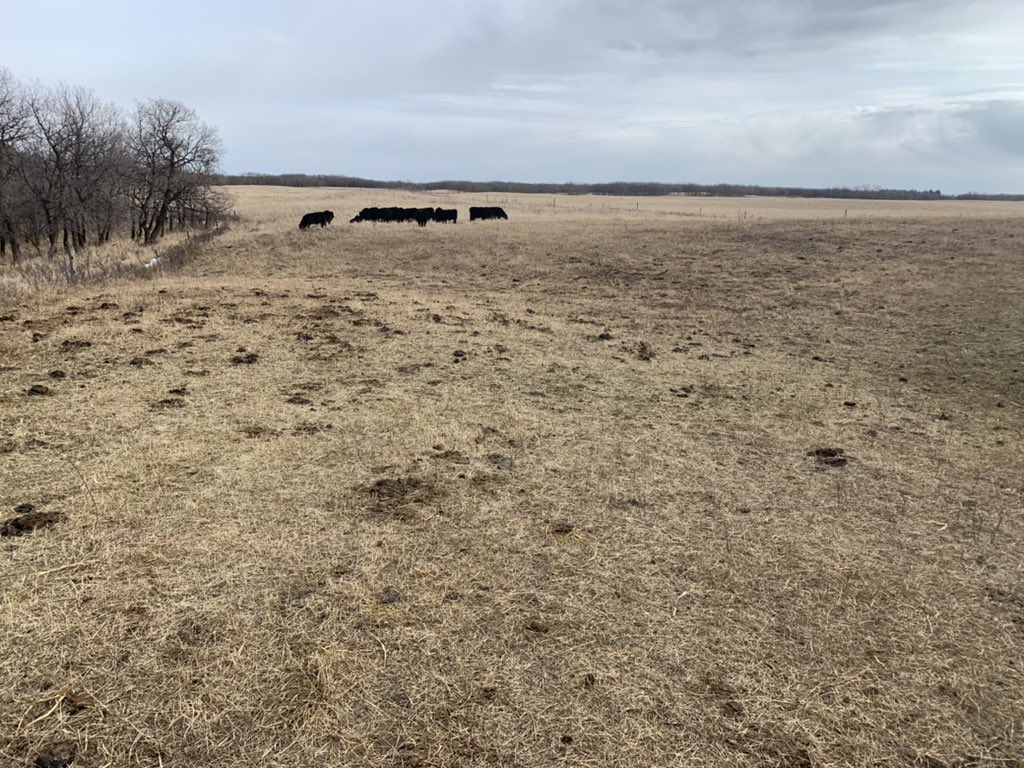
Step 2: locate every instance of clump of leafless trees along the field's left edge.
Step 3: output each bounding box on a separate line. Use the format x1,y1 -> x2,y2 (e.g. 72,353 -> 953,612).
0,68 -> 227,273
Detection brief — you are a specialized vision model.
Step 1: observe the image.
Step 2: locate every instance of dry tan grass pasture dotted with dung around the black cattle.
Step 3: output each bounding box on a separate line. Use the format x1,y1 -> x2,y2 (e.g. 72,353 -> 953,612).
0,187 -> 1024,768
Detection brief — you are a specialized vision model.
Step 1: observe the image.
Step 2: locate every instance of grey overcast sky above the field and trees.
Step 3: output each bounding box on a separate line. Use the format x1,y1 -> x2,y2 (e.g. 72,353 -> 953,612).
6,0 -> 1024,193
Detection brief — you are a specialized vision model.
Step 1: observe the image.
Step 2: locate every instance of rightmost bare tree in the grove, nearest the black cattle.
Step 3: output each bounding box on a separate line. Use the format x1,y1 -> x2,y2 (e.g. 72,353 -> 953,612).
128,99 -> 221,244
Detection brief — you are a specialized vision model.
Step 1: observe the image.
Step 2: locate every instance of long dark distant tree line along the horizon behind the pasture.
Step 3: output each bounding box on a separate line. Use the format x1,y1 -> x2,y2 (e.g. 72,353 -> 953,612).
221,173 -> 1024,201
